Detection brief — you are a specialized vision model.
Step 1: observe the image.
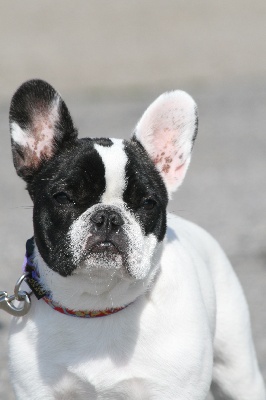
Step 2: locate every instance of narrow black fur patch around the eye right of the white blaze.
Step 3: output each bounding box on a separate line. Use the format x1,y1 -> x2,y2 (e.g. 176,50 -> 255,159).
123,138 -> 168,241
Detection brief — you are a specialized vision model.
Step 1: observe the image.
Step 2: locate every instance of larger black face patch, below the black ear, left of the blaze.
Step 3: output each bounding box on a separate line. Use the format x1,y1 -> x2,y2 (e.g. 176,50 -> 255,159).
29,139 -> 106,276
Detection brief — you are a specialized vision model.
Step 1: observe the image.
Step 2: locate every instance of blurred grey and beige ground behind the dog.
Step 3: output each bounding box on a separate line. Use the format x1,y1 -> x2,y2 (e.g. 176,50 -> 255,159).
0,0 -> 266,400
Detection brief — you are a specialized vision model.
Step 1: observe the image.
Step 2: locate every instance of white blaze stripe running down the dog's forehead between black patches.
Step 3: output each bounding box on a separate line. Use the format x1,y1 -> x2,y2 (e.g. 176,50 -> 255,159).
94,139 -> 127,203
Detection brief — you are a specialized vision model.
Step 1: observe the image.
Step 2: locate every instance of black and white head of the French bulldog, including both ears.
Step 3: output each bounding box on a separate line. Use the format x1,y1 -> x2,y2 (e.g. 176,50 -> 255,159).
10,80 -> 197,288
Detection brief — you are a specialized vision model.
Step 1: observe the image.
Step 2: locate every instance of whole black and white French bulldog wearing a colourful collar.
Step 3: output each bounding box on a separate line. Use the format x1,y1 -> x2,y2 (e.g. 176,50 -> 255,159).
9,80 -> 266,400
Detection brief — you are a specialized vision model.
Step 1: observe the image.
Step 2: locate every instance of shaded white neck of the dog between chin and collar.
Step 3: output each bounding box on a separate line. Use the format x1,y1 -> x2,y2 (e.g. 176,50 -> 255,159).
31,245 -> 162,312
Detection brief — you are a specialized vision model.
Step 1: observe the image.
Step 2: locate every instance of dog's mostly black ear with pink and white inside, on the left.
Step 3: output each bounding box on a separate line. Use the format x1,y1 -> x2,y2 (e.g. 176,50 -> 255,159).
9,80 -> 77,182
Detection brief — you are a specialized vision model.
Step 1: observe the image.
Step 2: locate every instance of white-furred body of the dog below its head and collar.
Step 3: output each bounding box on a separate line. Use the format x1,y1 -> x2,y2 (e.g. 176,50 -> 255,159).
10,215 -> 265,400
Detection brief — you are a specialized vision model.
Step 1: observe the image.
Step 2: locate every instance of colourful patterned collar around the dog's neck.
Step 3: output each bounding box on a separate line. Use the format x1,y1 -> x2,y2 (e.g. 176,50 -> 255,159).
22,237 -> 129,318
